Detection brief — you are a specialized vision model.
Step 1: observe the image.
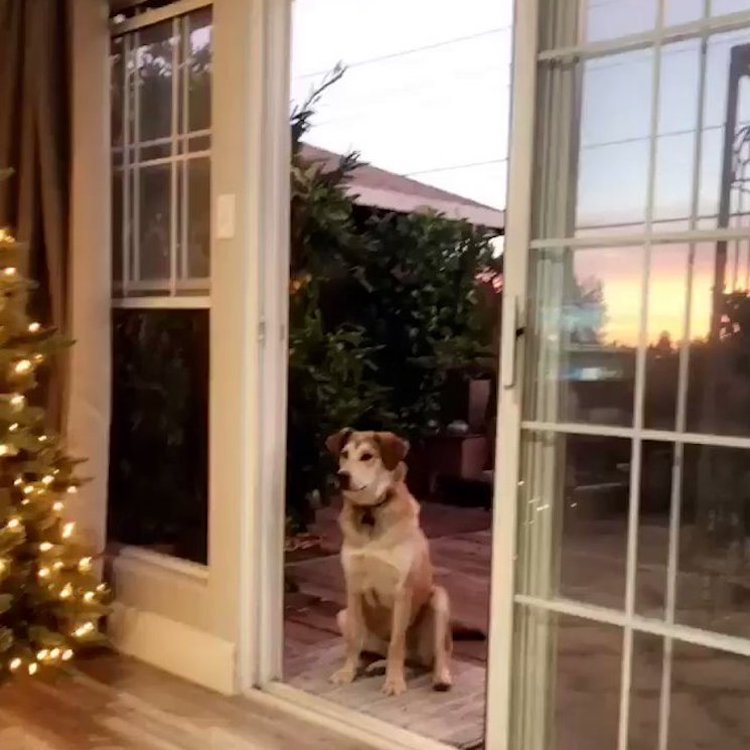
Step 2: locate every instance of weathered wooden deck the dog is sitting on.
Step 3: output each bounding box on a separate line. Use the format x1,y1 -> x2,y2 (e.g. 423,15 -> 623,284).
285,504 -> 491,749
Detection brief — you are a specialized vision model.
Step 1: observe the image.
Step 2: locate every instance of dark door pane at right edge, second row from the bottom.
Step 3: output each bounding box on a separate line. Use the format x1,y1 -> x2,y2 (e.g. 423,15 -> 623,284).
675,445 -> 750,638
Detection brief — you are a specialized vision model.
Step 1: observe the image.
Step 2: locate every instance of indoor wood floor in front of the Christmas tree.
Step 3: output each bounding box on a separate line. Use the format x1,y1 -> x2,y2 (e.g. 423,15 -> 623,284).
0,654 -> 376,750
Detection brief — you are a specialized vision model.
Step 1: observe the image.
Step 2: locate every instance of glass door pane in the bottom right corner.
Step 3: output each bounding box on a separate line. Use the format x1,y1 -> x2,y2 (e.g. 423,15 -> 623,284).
669,642 -> 750,750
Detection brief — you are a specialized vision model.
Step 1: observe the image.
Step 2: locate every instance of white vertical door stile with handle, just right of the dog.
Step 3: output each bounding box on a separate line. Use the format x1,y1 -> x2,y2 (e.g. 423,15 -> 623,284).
485,0 -> 539,750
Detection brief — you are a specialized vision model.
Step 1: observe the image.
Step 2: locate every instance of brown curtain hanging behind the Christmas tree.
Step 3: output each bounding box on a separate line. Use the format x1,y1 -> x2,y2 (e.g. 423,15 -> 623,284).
0,0 -> 70,428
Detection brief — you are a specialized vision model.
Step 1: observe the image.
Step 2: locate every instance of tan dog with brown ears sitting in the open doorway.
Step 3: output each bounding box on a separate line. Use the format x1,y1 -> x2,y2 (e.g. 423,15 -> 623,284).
326,429 -> 468,696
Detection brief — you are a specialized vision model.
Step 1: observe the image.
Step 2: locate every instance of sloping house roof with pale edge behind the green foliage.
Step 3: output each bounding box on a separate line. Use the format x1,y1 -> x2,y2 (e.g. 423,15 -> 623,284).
302,143 -> 505,234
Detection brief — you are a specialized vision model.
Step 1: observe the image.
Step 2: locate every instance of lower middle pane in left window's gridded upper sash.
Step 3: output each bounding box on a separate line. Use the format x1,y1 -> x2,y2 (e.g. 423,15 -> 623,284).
135,164 -> 172,288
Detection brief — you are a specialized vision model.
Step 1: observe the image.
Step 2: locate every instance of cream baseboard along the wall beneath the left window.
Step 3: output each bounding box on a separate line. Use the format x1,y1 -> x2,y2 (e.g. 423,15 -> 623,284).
107,602 -> 237,695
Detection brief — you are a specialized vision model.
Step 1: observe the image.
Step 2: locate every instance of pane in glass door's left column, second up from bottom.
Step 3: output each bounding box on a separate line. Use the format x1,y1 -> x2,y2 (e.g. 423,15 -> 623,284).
517,432 -> 631,610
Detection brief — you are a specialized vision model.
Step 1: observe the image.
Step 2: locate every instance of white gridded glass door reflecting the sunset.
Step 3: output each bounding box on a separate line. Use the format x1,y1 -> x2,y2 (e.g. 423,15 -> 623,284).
487,0 -> 750,750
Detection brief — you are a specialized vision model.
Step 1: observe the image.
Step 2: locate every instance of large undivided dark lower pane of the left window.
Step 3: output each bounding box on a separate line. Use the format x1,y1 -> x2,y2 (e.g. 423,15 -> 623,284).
108,310 -> 209,563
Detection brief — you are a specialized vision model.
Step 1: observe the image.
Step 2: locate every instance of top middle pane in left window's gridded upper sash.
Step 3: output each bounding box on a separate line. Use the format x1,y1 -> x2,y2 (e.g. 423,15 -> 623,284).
135,21 -> 178,142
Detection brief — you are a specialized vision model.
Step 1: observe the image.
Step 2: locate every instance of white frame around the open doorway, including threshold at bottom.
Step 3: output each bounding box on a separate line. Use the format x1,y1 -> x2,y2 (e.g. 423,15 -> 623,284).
239,0 -> 538,750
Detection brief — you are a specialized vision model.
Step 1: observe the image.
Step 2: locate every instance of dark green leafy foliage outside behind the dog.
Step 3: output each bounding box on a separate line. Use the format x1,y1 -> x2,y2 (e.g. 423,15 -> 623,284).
287,68 -> 506,523
